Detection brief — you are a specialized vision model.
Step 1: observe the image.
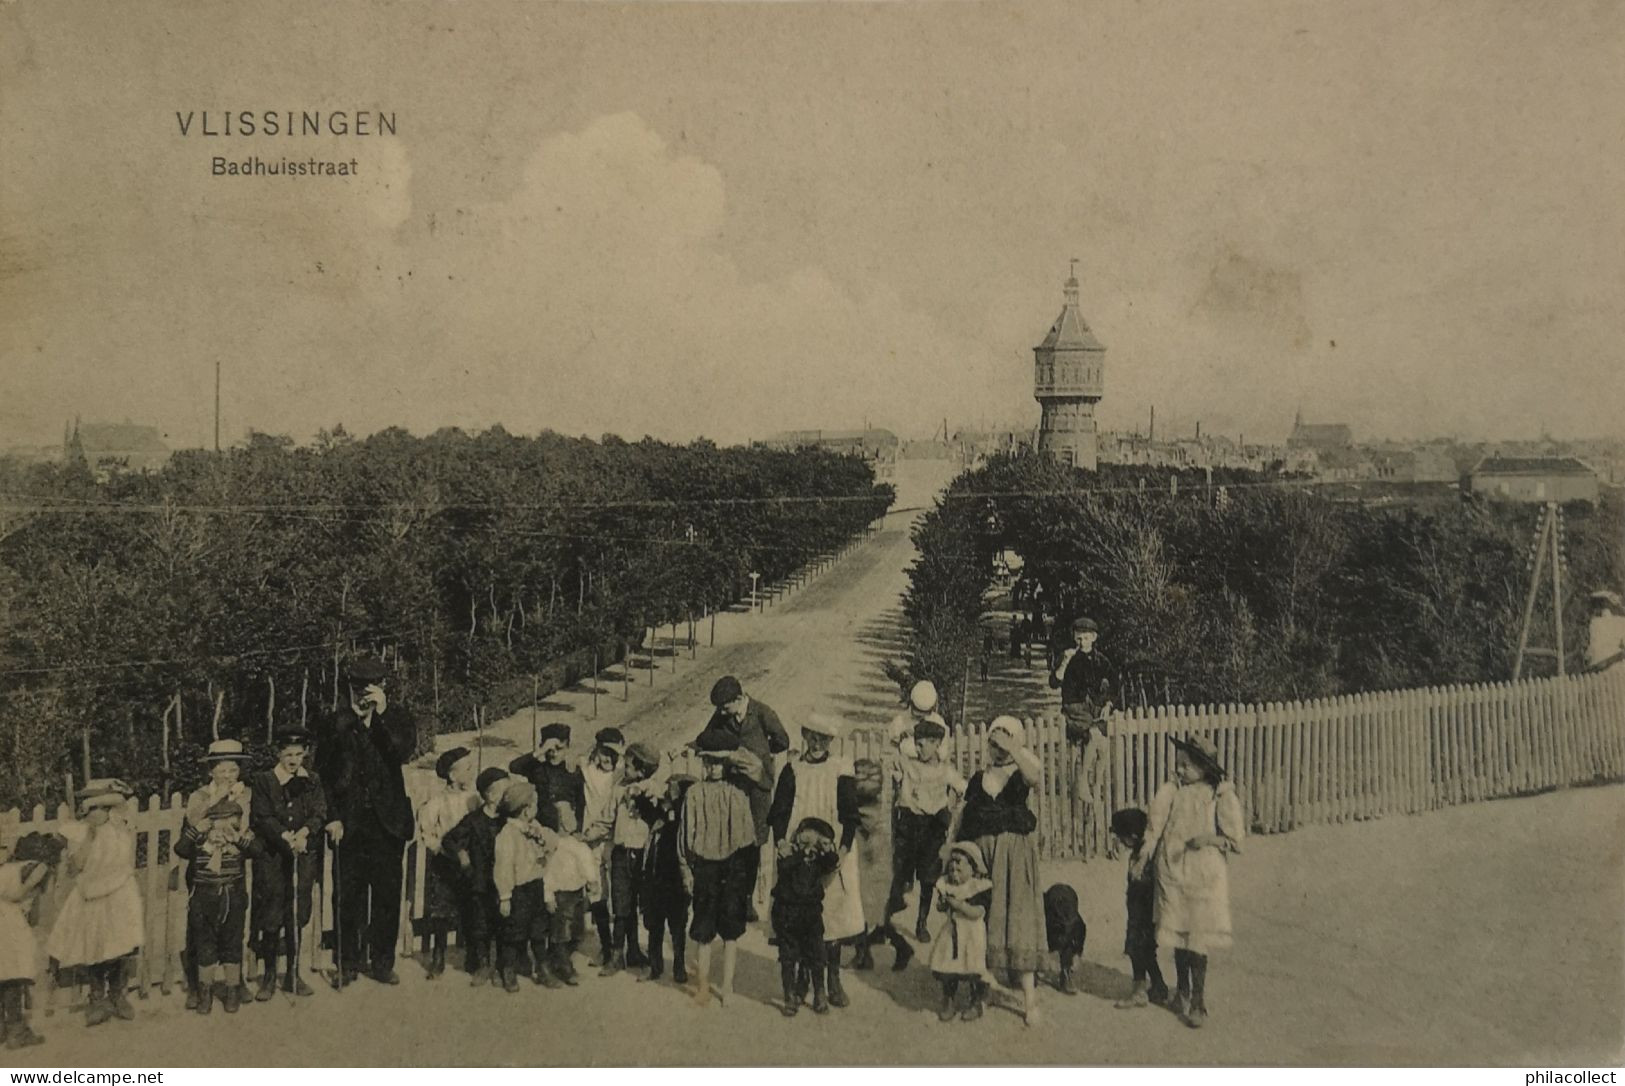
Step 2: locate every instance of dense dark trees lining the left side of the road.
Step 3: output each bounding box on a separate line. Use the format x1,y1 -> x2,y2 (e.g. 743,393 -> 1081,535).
0,428 -> 892,806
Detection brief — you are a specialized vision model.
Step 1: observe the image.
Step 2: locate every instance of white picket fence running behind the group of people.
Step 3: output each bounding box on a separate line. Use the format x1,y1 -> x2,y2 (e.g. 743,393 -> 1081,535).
0,667 -> 1625,1013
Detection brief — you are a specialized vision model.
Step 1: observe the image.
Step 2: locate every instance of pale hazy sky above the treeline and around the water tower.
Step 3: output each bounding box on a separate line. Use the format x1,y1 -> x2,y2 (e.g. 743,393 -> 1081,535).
0,0 -> 1625,447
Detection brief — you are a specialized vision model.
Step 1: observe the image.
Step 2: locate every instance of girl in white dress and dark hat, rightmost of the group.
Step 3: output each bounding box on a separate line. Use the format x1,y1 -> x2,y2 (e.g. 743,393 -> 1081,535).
1134,736 -> 1246,1029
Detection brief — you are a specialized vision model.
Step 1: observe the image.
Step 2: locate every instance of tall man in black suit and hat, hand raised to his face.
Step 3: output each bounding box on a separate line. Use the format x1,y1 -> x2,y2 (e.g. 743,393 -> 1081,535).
317,660 -> 418,984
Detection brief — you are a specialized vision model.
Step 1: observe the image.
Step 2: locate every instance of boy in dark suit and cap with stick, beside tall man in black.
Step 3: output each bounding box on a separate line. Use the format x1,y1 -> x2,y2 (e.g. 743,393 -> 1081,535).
249,728 -> 327,1003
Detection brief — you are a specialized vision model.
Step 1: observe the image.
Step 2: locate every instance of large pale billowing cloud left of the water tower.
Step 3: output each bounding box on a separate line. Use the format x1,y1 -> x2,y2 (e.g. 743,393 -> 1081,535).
372,114 -> 988,441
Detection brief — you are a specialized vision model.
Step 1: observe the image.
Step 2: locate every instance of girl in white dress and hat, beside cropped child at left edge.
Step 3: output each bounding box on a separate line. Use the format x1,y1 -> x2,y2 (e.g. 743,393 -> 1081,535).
46,777 -> 145,1026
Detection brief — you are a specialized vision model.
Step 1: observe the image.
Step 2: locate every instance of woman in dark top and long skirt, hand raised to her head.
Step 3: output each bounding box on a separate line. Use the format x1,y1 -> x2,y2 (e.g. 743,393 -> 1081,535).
956,717 -> 1048,1026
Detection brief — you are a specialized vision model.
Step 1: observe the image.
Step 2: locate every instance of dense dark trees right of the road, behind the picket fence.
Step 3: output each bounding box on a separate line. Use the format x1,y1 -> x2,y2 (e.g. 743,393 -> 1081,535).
905,455 -> 1625,715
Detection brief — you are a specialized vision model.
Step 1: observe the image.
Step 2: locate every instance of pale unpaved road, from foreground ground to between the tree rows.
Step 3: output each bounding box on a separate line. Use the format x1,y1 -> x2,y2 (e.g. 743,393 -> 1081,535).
25,463 -> 1625,1068
